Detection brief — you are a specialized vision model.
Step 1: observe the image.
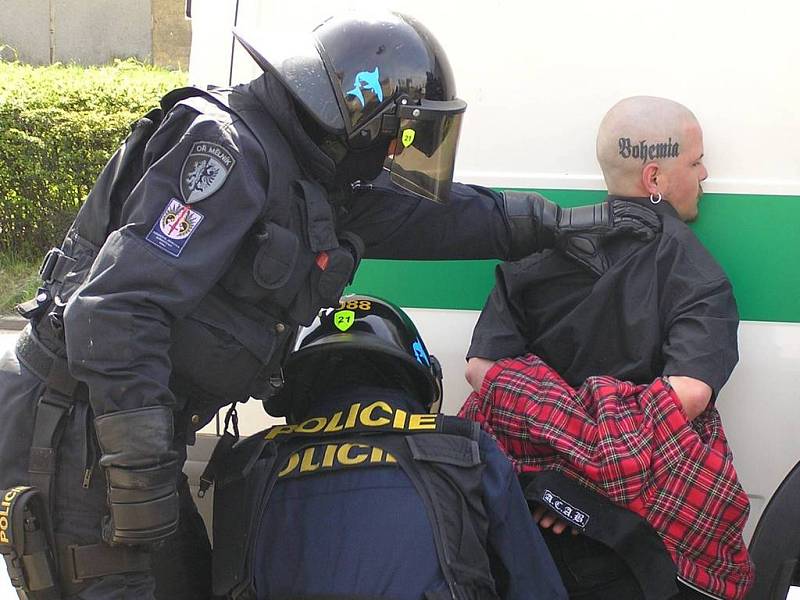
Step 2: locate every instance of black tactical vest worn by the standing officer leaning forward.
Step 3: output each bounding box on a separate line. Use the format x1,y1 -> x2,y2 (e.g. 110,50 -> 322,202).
25,88 -> 363,416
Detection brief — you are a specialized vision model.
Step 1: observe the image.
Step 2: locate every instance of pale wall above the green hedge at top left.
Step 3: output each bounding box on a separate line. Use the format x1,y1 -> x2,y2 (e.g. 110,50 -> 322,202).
0,0 -> 191,69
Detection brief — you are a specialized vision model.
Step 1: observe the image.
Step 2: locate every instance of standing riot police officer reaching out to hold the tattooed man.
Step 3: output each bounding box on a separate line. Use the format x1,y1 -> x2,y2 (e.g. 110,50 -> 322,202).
0,13 -> 658,599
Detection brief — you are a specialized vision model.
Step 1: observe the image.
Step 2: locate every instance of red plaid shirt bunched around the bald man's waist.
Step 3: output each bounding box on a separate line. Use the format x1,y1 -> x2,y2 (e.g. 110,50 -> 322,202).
460,354 -> 753,599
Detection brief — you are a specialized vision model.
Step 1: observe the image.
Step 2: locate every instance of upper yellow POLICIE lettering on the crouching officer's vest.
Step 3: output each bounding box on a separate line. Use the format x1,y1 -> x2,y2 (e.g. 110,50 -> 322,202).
264,400 -> 438,440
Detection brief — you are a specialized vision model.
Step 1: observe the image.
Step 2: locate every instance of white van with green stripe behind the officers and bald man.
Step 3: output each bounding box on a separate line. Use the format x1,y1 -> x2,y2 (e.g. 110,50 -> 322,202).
188,0 -> 800,596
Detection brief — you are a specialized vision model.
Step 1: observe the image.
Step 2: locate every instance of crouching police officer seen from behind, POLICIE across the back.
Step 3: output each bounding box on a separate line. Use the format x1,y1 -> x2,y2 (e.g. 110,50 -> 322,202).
209,295 -> 566,600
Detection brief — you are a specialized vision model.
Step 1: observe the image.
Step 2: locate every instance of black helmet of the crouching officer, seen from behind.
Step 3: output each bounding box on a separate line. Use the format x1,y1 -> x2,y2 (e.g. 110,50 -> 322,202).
283,295 -> 442,419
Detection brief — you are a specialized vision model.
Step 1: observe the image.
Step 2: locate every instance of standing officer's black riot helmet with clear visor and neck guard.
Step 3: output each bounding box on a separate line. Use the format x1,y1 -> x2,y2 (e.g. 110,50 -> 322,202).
234,12 -> 466,202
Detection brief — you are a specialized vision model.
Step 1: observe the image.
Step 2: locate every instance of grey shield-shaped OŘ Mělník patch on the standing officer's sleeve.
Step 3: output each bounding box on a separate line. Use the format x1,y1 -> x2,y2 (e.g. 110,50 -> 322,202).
181,142 -> 236,204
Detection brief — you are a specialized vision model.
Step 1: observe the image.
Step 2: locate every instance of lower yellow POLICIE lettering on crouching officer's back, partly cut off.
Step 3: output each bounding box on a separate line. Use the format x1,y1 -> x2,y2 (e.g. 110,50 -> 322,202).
278,442 -> 397,478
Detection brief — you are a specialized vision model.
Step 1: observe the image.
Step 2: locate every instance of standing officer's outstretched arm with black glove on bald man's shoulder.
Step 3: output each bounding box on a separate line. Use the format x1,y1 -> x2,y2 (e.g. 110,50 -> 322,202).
340,178 -> 661,273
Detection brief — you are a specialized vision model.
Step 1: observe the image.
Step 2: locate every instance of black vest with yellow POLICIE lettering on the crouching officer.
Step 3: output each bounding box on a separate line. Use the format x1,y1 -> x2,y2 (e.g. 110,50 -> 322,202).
213,403 -> 498,600
